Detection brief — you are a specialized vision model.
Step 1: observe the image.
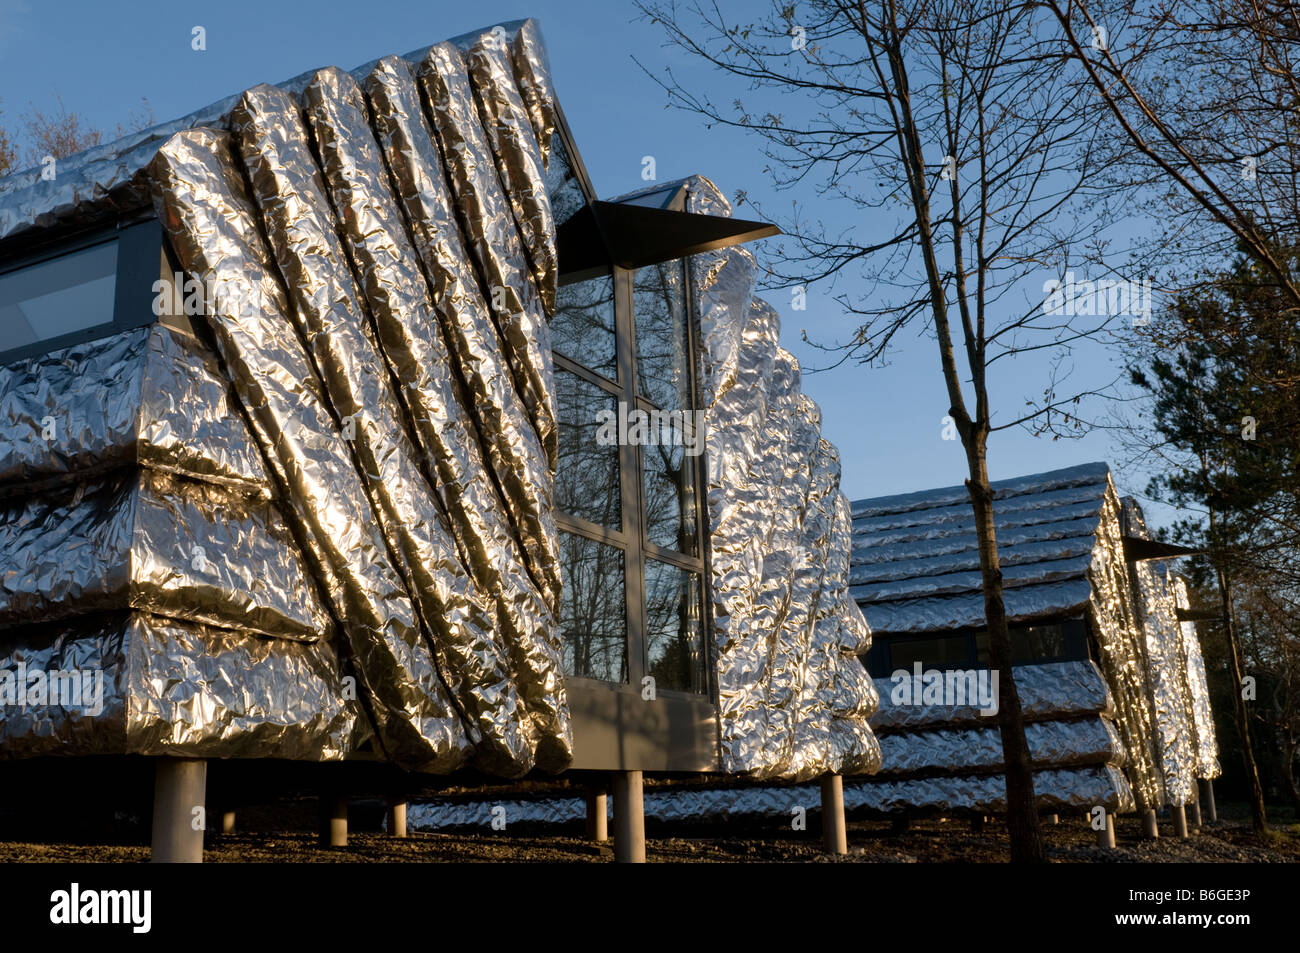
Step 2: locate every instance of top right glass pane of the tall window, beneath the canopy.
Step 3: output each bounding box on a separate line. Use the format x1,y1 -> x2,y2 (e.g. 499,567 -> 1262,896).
632,260 -> 690,411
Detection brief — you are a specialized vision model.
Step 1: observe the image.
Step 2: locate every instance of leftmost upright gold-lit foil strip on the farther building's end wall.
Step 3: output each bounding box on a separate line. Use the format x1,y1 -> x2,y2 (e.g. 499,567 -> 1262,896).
1088,477 -> 1165,810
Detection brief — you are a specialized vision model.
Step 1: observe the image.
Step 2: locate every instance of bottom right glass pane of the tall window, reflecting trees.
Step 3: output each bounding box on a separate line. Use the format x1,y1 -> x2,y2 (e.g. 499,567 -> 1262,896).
646,559 -> 707,694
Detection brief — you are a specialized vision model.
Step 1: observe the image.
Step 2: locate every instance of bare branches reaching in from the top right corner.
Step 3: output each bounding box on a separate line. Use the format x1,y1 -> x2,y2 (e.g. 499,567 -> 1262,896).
1045,0 -> 1300,309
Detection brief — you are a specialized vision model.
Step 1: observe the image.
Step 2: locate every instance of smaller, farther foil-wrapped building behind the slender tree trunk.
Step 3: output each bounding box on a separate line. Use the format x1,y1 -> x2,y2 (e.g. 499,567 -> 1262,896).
850,464 -> 1213,813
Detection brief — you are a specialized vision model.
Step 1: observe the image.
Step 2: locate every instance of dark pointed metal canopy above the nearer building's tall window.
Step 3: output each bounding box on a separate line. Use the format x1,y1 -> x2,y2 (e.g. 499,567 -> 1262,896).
556,200 -> 780,281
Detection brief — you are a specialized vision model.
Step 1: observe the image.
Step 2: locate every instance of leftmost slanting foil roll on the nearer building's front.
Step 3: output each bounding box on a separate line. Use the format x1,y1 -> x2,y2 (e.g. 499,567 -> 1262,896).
150,129 -> 469,772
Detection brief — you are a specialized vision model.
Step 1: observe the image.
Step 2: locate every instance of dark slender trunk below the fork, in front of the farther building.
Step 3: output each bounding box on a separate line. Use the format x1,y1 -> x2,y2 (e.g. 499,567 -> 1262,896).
966,441 -> 1047,863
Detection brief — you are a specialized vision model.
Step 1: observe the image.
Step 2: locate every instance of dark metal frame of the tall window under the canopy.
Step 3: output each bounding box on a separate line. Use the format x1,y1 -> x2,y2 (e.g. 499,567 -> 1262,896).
553,256 -> 718,707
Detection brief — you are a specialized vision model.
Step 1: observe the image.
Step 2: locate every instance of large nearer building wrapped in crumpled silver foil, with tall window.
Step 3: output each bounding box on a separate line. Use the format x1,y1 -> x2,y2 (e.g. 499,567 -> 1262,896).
0,21 -> 880,811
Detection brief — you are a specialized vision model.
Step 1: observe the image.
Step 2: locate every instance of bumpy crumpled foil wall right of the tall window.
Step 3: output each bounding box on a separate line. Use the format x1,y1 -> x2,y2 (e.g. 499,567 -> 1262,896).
686,178 -> 880,780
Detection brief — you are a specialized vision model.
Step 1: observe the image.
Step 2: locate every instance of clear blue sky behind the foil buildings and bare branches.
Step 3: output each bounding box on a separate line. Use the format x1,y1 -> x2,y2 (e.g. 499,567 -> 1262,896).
0,0 -> 1164,523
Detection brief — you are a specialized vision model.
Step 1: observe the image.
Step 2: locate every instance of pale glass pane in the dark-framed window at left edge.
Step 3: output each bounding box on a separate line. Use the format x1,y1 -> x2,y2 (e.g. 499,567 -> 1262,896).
0,241 -> 117,350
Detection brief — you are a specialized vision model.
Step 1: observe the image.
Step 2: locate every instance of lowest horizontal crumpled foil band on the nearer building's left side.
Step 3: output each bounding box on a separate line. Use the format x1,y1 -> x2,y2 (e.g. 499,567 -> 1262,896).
0,612 -> 367,761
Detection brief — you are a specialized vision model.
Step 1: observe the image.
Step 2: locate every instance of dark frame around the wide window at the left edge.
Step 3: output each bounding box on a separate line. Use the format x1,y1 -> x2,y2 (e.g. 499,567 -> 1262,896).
0,217 -> 168,365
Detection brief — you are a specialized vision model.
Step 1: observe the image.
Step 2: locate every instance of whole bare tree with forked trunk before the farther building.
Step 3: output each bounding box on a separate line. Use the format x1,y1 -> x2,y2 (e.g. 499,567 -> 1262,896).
641,0 -> 1149,861
